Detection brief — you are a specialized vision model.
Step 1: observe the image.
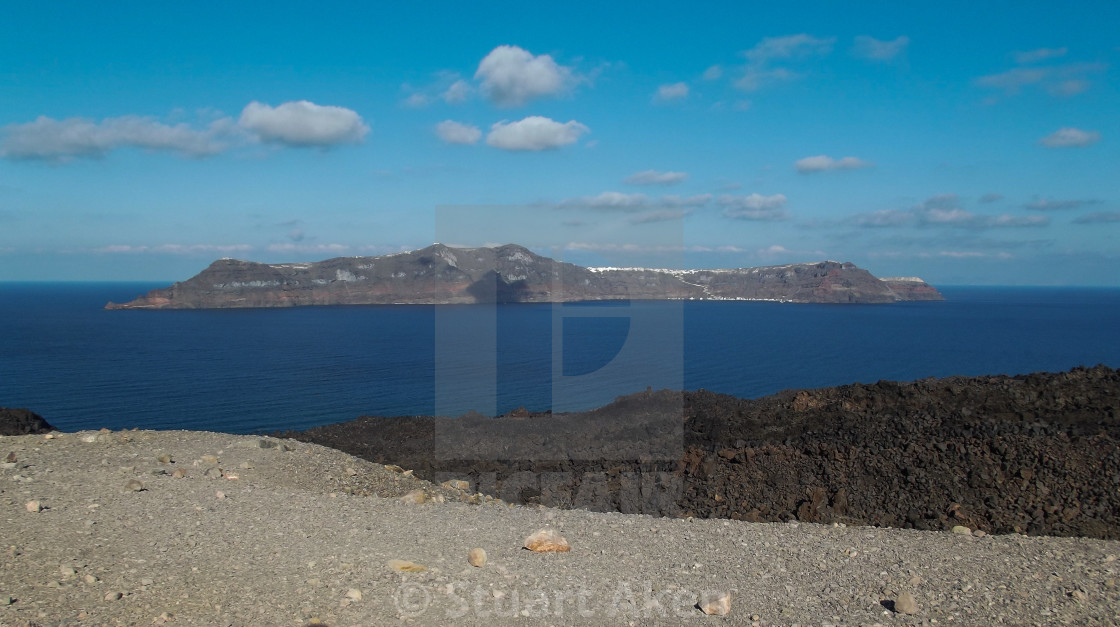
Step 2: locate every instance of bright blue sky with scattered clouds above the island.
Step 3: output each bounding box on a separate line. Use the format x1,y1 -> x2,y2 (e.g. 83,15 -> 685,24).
0,1 -> 1120,286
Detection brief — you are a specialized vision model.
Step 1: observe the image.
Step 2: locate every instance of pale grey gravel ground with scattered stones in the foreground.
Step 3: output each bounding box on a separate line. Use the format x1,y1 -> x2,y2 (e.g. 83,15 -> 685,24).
0,431 -> 1120,626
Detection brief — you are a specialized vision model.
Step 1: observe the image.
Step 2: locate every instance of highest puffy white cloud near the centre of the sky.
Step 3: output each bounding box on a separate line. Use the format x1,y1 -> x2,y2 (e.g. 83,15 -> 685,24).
475,46 -> 572,106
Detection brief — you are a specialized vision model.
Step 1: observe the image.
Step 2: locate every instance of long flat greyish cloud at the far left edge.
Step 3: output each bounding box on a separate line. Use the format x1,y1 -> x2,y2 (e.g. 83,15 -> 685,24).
0,115 -> 236,161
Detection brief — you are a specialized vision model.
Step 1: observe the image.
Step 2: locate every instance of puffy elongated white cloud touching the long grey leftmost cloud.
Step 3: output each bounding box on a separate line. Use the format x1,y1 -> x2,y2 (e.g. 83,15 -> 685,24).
237,100 -> 370,148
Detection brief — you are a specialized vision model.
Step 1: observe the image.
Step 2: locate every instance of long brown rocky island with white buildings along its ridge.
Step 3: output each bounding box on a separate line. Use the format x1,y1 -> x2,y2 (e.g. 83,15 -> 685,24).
105,244 -> 942,309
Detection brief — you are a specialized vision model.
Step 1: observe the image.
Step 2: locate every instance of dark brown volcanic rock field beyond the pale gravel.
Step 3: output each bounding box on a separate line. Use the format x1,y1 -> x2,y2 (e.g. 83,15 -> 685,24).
275,366 -> 1120,539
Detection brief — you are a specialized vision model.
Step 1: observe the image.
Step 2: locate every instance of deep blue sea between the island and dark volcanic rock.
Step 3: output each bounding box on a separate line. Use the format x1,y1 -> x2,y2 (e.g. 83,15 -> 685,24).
0,283 -> 1120,433
